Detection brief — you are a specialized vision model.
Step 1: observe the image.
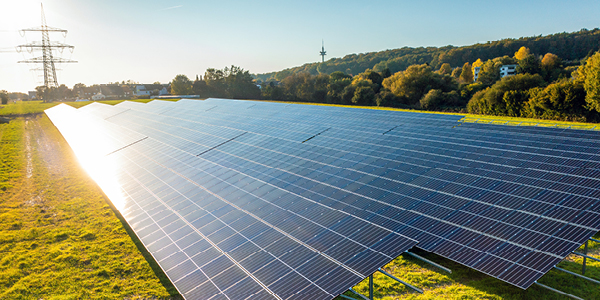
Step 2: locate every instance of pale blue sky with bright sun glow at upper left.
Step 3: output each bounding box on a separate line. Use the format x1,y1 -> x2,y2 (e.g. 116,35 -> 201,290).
0,0 -> 600,92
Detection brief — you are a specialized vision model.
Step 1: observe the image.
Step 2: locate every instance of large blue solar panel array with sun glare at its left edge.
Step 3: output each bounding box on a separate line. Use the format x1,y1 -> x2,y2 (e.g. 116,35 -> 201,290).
46,99 -> 600,299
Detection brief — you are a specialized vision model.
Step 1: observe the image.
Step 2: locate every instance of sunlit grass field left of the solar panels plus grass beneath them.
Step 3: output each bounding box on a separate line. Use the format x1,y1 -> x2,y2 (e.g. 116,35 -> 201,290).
0,100 -> 600,300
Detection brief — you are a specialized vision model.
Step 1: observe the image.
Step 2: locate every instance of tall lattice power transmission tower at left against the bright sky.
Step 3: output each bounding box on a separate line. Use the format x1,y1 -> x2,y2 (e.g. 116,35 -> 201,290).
17,4 -> 76,90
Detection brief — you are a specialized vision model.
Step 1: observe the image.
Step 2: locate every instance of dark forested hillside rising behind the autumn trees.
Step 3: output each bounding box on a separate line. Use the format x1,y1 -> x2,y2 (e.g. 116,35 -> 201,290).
254,28 -> 600,81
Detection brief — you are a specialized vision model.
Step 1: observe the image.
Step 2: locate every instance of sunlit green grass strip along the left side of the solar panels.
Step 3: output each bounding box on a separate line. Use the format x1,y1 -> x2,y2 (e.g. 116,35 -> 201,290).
0,116 -> 180,299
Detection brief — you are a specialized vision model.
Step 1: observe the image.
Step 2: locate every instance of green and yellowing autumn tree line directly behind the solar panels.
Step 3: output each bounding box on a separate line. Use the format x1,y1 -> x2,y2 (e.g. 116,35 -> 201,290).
171,47 -> 600,122
